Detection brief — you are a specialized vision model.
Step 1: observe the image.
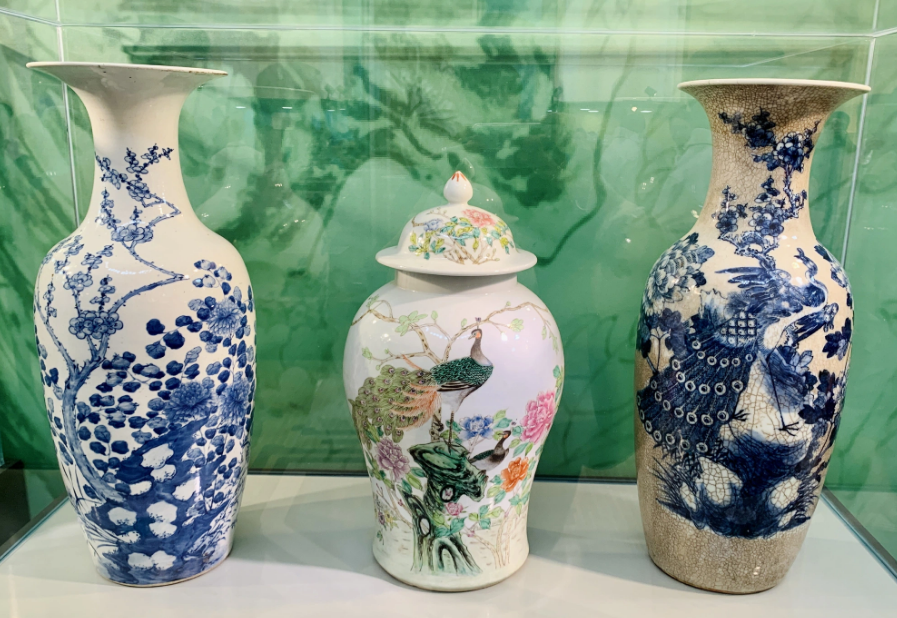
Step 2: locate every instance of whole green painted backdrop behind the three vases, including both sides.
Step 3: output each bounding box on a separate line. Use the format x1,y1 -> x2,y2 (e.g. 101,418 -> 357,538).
0,0 -> 897,546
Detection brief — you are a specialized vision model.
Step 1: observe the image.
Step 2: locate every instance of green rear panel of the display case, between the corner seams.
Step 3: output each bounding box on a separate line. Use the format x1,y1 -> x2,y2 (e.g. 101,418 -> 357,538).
57,27 -> 869,476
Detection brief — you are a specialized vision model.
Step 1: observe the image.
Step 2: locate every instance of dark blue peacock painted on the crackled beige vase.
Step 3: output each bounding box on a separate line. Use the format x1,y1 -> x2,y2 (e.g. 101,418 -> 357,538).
637,249 -> 837,459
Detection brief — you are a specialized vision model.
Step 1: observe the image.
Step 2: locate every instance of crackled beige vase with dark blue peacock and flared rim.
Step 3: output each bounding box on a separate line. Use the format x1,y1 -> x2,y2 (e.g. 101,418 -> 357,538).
635,80 -> 869,593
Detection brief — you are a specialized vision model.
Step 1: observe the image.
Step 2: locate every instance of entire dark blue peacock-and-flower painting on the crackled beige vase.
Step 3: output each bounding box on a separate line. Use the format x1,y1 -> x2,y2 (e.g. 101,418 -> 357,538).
636,109 -> 852,538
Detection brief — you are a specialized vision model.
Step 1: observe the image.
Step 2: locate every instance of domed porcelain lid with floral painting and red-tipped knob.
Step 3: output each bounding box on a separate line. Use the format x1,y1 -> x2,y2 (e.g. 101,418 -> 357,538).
377,172 -> 536,277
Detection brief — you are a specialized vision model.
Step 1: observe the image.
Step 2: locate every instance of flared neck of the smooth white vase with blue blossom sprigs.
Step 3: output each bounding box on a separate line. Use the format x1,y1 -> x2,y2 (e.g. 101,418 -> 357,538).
30,63 -> 224,227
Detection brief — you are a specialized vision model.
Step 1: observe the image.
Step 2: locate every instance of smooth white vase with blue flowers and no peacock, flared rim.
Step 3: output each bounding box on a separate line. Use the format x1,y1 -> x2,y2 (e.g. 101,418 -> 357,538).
28,62 -> 255,586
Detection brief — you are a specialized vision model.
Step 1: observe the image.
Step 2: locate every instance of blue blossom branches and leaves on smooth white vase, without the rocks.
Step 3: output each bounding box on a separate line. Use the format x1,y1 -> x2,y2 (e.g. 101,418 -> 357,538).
34,141 -> 256,536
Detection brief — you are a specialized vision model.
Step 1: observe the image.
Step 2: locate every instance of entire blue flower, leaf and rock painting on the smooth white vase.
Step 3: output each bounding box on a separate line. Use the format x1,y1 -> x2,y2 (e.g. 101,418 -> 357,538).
34,146 -> 256,585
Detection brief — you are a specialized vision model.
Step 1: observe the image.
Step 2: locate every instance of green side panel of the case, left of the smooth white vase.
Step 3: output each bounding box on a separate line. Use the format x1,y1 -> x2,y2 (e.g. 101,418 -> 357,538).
0,14 -> 75,545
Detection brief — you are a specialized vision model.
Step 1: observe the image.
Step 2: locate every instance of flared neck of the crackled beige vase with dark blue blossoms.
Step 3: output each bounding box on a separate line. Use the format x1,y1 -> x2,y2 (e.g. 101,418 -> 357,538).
683,81 -> 865,243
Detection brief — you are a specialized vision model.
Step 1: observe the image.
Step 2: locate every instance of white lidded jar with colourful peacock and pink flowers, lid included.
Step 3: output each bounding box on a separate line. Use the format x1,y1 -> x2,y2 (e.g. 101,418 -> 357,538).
343,172 -> 564,590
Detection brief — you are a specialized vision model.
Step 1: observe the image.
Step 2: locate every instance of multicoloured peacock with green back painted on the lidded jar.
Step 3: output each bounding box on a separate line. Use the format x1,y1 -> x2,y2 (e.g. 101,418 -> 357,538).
349,327 -> 494,446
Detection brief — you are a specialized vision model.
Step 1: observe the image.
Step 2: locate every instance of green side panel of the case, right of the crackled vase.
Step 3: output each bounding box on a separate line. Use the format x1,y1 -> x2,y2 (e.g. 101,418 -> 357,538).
827,30 -> 897,555
